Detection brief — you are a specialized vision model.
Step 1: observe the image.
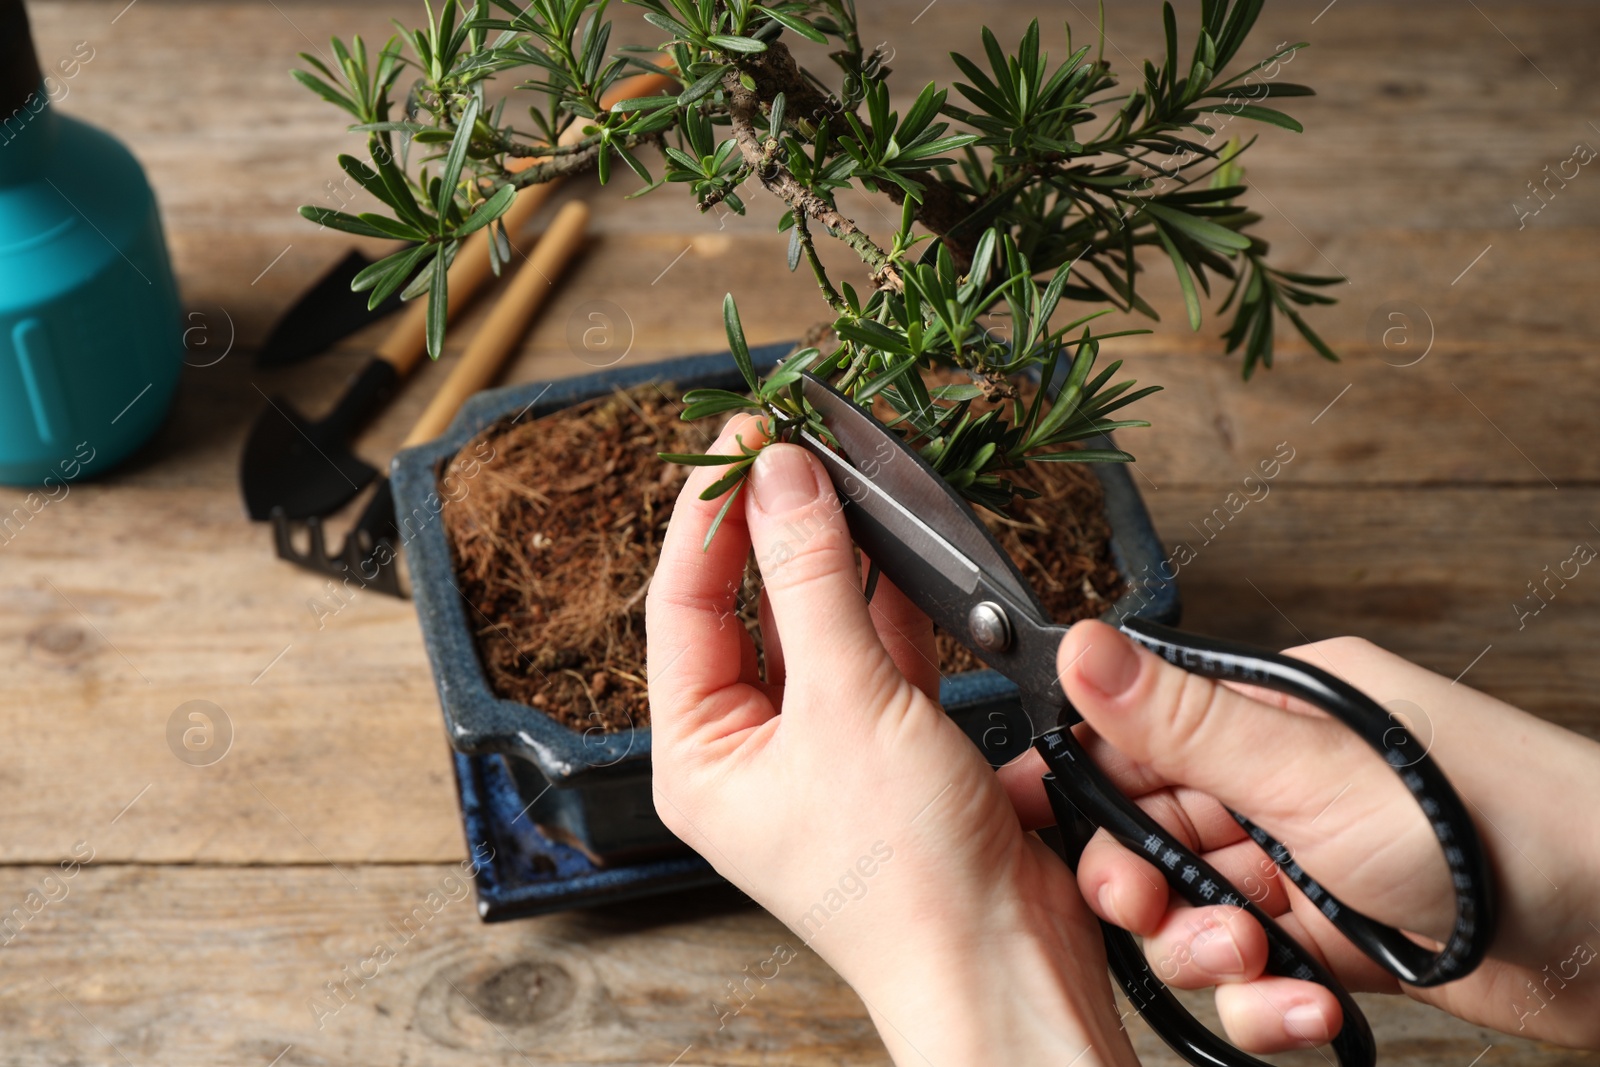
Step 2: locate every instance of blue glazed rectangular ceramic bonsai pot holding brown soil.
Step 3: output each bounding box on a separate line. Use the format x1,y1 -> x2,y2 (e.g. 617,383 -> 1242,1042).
392,344 -> 1179,883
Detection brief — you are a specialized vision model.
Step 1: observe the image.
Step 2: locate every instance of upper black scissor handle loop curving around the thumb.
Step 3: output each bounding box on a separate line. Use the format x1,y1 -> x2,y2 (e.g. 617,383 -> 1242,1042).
1113,619 -> 1498,987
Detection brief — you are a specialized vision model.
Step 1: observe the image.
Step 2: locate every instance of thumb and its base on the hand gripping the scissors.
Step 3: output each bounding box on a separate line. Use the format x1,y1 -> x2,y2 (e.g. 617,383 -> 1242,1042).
1058,622 -> 1448,921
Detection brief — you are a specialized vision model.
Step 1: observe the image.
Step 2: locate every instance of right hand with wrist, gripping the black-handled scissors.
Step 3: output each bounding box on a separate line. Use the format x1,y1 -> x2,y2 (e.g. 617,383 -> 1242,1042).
1002,622 -> 1600,1053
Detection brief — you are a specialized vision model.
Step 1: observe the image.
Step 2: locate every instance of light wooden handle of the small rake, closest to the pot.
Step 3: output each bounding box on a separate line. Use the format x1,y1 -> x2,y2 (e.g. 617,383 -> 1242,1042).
400,200 -> 589,448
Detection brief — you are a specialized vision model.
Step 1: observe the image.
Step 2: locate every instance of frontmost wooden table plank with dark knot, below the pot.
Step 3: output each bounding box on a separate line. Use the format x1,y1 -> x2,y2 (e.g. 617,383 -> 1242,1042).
0,865 -> 1590,1067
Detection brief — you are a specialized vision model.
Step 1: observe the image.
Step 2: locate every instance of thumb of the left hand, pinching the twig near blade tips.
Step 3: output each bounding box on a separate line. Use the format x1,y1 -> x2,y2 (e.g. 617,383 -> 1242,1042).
746,443 -> 901,701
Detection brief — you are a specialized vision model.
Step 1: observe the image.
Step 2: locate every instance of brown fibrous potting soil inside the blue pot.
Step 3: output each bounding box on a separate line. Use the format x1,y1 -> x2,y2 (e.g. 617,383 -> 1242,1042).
443,386 -> 1123,731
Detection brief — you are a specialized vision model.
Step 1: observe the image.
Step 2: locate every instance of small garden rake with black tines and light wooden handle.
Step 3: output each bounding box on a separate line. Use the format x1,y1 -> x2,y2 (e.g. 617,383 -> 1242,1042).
270,200 -> 589,597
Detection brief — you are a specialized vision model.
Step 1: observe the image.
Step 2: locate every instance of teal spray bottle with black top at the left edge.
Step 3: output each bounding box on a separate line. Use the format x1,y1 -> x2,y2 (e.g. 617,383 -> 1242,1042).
0,0 -> 184,491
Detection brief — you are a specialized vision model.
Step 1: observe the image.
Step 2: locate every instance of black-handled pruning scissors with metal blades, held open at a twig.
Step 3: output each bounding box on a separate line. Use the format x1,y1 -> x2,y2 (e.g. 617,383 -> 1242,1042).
798,374 -> 1496,1067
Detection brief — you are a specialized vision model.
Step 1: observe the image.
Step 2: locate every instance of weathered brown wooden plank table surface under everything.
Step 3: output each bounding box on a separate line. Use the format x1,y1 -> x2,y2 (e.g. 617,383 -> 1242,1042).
0,0 -> 1600,1067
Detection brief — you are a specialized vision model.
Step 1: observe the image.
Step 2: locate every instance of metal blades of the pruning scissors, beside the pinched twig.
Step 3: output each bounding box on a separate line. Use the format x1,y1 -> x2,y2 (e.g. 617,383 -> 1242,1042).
802,374 -> 1050,622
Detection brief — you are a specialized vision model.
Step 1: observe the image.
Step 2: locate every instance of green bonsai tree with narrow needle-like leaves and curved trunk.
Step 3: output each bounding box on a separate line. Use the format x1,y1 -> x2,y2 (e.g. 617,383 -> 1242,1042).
294,0 -> 1339,534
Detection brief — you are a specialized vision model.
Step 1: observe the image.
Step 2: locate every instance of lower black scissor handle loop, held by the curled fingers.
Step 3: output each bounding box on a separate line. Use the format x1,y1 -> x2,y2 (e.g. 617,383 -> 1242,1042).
1034,726 -> 1378,1067
